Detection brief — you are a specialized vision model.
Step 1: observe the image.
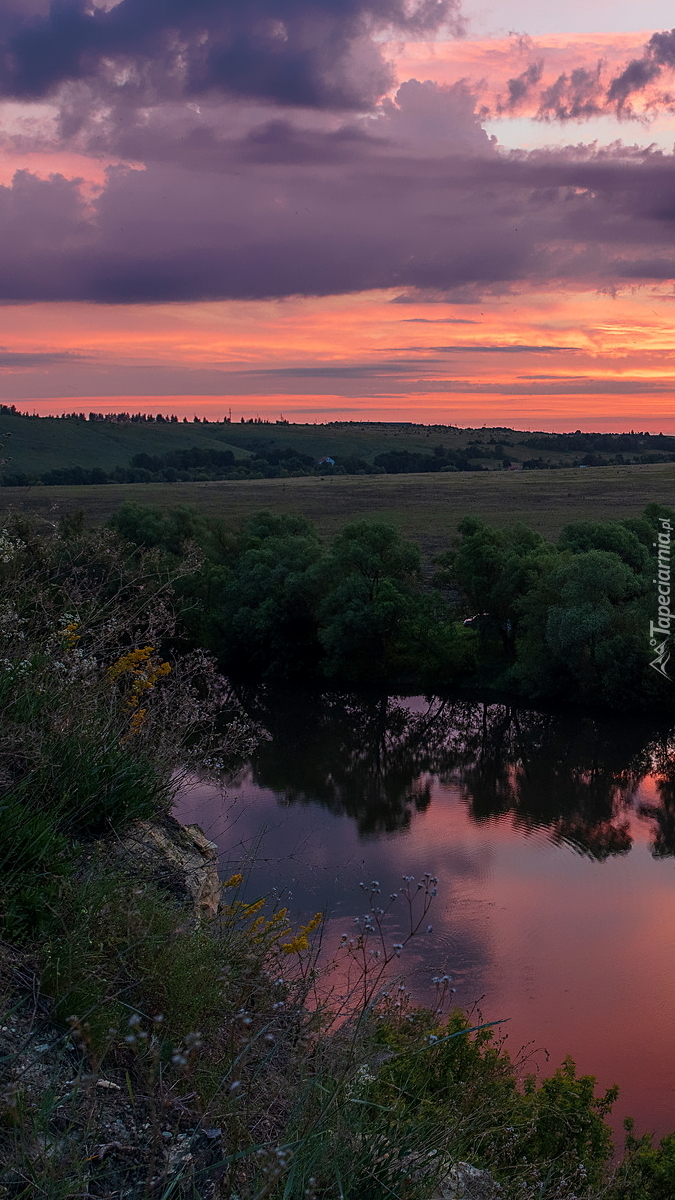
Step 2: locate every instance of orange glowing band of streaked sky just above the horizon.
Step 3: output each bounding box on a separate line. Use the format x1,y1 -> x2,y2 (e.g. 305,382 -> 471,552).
0,288 -> 675,432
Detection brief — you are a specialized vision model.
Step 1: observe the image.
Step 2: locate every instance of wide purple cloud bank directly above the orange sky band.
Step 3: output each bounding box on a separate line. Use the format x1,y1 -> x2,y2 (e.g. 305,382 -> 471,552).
0,82 -> 675,302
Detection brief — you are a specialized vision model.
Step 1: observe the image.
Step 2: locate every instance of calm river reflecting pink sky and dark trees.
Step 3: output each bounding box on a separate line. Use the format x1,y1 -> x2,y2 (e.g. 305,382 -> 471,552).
171,691 -> 675,1135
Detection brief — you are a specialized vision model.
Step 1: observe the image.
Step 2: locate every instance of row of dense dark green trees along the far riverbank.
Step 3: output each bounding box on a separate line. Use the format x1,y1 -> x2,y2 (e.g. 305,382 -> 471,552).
110,504 -> 675,708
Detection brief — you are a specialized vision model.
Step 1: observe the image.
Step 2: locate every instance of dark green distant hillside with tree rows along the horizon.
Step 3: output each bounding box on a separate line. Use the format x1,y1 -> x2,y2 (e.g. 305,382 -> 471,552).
0,406 -> 675,486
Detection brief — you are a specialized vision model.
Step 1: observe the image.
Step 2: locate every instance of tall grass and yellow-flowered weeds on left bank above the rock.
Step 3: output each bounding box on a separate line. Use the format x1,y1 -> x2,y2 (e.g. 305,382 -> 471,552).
0,511 -> 251,936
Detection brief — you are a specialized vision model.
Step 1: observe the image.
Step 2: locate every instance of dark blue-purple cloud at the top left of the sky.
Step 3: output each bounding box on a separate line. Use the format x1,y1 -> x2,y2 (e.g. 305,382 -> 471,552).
0,0 -> 459,107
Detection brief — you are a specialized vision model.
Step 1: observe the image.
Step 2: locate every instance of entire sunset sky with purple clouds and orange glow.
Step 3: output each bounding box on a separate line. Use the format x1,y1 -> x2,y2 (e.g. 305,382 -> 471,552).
0,0 -> 675,432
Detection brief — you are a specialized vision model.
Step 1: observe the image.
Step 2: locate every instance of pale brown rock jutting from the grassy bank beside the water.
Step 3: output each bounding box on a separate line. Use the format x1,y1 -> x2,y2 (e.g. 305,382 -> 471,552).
117,815 -> 221,917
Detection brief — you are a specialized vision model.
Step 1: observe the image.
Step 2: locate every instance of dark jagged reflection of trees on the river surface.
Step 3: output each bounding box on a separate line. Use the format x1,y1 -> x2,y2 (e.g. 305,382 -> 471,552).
228,689 -> 675,860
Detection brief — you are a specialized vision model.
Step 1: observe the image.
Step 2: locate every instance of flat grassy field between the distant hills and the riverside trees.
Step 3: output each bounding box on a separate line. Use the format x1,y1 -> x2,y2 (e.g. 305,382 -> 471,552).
0,463 -> 675,556
